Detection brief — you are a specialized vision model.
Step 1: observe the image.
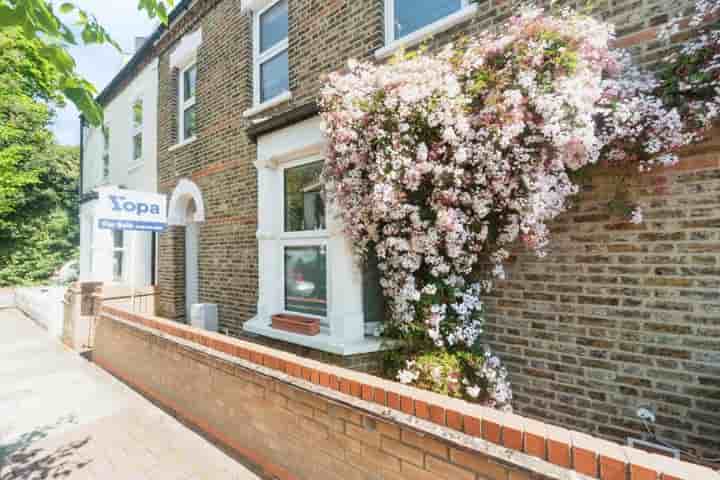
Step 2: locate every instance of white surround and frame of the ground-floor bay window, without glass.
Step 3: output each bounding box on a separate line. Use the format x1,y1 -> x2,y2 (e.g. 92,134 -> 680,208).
244,117 -> 381,355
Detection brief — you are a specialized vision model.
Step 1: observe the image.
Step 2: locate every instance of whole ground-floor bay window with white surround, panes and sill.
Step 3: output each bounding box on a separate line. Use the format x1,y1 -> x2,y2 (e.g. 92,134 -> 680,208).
243,117 -> 384,355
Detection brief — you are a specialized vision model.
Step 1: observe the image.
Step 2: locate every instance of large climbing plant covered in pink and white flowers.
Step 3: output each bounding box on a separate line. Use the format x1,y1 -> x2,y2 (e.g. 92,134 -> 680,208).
321,4 -> 720,406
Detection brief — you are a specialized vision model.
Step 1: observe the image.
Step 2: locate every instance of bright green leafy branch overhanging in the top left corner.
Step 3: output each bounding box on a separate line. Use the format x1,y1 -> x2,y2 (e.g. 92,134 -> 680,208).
0,0 -> 174,126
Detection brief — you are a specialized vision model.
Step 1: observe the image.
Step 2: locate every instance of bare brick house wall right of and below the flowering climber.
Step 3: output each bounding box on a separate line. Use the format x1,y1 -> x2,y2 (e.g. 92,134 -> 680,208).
486,139 -> 720,457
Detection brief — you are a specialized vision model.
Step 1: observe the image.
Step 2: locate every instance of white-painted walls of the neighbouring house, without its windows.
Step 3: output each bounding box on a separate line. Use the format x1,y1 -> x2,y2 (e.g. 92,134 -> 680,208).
80,60 -> 159,287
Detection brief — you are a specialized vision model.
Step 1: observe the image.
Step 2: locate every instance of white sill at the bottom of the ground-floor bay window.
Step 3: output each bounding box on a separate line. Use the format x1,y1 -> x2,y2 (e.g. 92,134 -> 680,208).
243,315 -> 388,356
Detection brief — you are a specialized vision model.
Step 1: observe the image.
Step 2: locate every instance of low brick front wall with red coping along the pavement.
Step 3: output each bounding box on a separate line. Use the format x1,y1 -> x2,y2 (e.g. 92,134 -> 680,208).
93,306 -> 720,480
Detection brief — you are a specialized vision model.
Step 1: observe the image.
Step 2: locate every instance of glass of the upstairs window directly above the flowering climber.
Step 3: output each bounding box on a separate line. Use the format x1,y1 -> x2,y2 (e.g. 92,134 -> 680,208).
385,0 -> 470,43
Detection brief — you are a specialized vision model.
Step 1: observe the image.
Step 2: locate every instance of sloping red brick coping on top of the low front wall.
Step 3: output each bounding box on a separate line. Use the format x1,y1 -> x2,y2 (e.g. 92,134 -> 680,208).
101,305 -> 720,480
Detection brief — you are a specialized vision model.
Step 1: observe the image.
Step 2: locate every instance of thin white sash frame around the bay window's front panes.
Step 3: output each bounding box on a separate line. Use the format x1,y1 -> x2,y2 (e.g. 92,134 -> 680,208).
276,155 -> 332,327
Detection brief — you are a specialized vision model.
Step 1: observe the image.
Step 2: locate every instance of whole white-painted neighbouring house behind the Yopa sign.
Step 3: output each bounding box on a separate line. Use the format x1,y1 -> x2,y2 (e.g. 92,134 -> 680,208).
80,55 -> 158,287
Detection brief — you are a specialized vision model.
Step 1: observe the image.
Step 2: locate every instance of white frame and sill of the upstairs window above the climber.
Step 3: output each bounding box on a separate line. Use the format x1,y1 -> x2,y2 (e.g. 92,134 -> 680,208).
375,0 -> 478,59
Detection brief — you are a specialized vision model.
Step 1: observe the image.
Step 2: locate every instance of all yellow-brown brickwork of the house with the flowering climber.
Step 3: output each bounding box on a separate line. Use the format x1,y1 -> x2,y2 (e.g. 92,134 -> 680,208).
149,0 -> 720,462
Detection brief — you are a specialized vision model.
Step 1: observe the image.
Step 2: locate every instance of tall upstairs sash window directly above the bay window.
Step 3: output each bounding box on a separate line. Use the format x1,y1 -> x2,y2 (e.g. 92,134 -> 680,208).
254,0 -> 290,104
